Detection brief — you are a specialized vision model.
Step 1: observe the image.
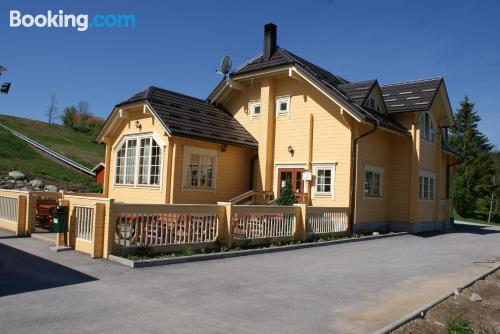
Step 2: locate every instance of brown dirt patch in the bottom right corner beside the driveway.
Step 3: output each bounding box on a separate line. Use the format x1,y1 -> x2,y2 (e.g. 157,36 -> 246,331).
391,269 -> 500,334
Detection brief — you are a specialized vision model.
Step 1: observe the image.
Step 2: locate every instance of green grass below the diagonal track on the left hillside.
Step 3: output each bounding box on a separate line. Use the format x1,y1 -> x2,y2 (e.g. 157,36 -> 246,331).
0,125 -> 99,191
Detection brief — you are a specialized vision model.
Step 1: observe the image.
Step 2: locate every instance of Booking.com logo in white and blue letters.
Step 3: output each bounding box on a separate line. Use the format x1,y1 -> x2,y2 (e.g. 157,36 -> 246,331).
10,9 -> 136,31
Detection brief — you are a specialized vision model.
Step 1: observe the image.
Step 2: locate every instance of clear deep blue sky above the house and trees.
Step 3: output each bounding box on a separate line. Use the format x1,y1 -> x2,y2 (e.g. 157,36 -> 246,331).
0,0 -> 500,149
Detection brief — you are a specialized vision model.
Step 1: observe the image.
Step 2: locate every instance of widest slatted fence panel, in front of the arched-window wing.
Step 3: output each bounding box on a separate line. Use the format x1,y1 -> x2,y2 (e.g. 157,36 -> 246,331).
115,205 -> 223,246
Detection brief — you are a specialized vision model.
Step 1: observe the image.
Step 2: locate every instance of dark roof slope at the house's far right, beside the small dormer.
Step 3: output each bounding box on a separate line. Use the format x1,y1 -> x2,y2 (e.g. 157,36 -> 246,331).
380,78 -> 443,113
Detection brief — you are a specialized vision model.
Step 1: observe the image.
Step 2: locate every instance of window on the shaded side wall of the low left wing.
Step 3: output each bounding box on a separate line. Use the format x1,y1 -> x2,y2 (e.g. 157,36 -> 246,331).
183,146 -> 217,190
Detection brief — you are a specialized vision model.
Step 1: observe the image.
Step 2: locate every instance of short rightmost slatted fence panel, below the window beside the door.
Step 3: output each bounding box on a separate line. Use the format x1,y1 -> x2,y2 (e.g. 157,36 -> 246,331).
307,206 -> 348,234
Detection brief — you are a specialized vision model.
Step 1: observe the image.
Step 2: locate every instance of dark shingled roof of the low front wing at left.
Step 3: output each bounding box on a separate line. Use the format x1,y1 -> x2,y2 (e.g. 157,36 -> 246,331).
117,86 -> 258,148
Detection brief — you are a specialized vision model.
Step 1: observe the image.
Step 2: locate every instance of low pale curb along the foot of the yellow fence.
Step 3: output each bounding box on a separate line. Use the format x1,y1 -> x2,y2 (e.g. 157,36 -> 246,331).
108,232 -> 408,268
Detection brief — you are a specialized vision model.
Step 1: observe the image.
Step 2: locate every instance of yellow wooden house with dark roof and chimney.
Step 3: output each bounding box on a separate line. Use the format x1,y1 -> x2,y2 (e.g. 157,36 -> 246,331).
97,24 -> 459,232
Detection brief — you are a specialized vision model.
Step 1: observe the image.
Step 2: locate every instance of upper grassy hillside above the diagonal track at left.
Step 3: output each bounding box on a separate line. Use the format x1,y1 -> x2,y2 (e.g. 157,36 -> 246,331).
0,115 -> 104,168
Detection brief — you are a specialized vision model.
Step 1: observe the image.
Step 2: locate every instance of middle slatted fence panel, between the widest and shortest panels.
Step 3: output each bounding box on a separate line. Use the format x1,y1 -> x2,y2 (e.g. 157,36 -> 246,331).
231,205 -> 298,240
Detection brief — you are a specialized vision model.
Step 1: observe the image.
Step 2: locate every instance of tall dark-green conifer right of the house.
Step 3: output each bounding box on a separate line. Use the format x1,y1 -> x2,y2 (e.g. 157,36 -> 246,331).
450,96 -> 494,217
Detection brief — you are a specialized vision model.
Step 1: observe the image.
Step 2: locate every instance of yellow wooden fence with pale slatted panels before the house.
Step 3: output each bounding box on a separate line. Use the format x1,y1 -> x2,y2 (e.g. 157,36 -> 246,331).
0,190 -> 348,258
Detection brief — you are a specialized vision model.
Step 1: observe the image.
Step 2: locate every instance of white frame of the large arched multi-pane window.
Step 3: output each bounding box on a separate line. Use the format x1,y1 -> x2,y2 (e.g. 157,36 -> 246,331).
112,132 -> 165,188
